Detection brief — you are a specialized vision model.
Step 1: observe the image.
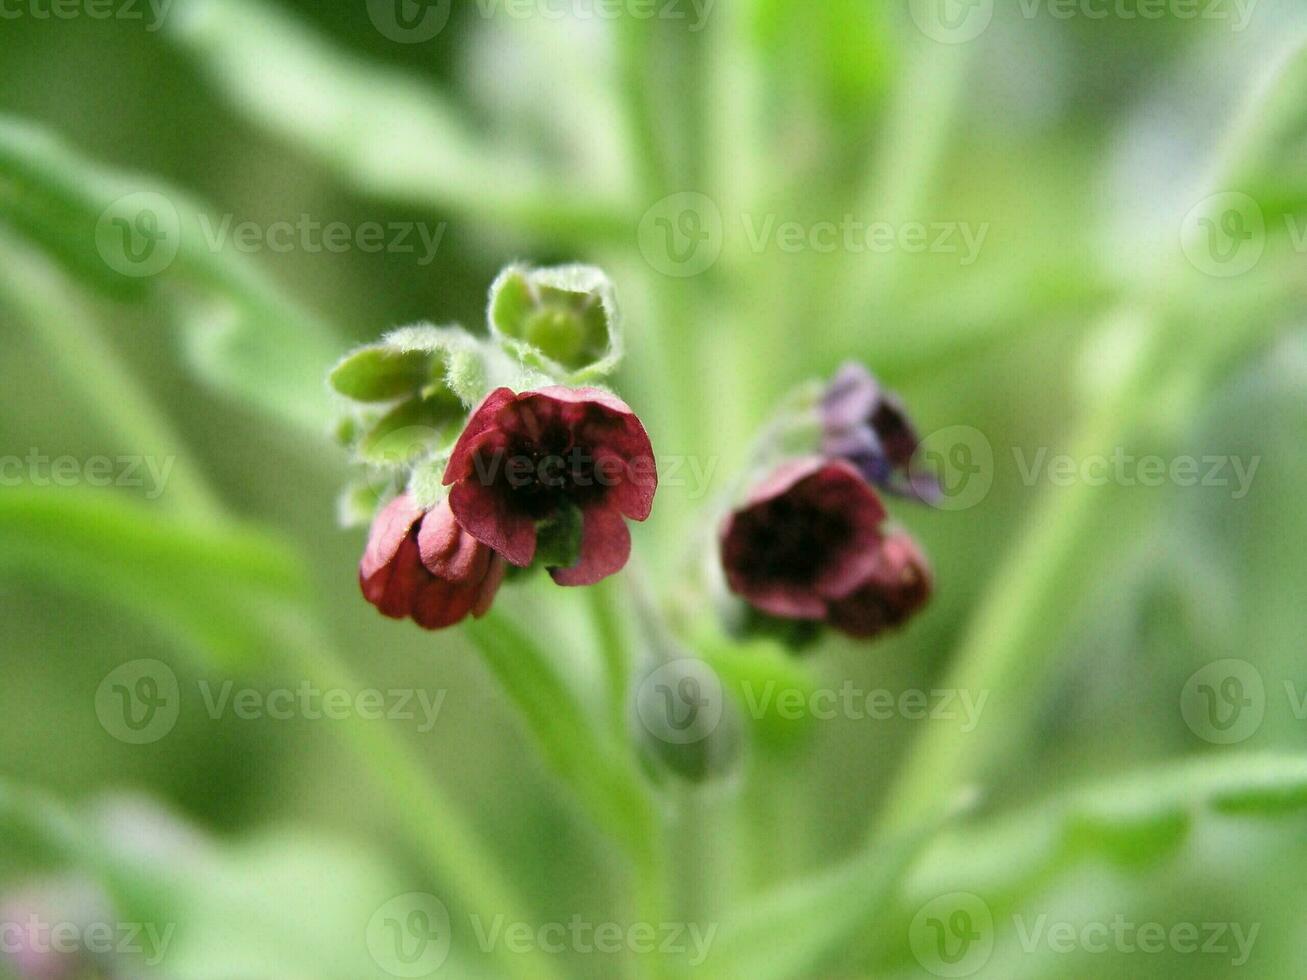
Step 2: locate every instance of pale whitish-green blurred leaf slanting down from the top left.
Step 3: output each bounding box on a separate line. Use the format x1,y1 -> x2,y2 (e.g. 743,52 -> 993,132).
166,0 -> 630,243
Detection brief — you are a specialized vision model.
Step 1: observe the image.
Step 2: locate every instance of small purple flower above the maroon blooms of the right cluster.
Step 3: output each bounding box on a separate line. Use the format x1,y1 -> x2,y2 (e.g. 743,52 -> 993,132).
821,362 -> 940,500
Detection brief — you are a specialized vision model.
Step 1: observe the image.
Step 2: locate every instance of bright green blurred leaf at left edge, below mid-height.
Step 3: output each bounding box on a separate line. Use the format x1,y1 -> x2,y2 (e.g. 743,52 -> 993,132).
0,486 -> 310,664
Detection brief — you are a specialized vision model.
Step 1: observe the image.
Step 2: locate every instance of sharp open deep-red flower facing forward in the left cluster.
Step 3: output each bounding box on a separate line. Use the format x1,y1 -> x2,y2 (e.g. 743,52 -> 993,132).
444,387 -> 657,585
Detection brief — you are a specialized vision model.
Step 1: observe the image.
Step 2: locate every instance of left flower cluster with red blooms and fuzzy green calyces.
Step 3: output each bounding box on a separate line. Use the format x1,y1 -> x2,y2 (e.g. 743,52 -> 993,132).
331,267 -> 657,630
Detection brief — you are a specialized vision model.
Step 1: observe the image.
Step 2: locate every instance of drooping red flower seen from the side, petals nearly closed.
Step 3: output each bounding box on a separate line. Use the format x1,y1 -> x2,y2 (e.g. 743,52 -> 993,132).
358,494 -> 507,630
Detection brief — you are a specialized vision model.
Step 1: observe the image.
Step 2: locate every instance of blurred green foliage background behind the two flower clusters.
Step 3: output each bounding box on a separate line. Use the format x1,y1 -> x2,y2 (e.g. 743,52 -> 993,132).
0,0 -> 1307,980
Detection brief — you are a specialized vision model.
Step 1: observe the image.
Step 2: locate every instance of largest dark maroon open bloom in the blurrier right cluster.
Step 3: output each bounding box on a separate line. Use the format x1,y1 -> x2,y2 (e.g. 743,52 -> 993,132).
721,459 -> 885,619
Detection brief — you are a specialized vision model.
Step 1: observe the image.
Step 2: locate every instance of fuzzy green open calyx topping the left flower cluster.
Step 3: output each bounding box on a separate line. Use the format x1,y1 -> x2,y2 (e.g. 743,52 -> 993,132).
489,265 -> 622,383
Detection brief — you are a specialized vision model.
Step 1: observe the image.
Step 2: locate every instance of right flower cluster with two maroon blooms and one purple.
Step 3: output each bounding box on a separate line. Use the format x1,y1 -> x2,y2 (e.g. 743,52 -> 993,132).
720,365 -> 935,639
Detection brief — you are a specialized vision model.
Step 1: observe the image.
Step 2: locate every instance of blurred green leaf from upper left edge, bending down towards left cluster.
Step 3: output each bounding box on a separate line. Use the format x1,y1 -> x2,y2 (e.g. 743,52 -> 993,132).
0,118 -> 336,433
